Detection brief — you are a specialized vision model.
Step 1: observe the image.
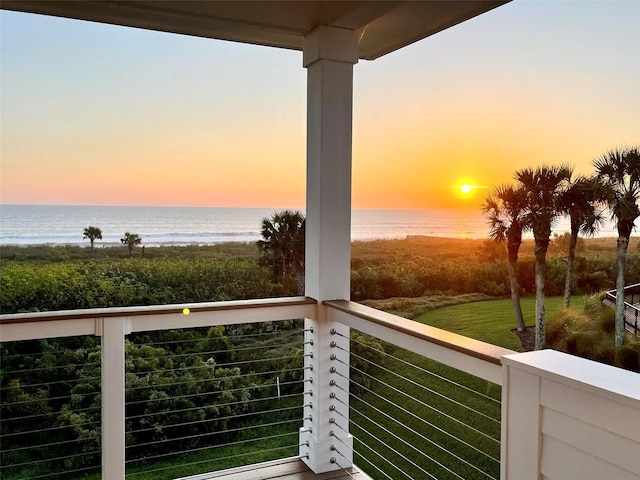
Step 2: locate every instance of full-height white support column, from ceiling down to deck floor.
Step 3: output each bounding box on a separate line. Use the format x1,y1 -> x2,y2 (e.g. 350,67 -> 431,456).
300,26 -> 358,473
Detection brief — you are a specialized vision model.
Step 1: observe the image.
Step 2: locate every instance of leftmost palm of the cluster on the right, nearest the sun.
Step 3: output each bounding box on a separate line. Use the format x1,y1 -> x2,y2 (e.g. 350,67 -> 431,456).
482,185 -> 529,332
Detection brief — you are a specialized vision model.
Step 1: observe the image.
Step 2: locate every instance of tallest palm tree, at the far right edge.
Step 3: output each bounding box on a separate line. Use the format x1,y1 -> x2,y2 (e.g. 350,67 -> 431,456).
593,147 -> 640,347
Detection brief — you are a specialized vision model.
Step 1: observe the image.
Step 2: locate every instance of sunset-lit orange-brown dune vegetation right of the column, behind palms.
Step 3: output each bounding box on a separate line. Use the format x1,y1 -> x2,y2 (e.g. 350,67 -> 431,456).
351,237 -> 640,301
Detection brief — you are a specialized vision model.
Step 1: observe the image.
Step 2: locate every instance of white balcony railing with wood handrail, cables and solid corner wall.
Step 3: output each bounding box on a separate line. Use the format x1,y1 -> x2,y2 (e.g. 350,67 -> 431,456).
0,297 -> 640,480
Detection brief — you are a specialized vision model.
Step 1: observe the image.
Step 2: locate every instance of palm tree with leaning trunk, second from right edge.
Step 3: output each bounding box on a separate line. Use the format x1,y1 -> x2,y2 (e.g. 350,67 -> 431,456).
558,176 -> 604,308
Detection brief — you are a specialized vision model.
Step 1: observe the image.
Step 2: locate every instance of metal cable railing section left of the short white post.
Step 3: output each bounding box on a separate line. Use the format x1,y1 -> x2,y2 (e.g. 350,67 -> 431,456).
0,336 -> 101,480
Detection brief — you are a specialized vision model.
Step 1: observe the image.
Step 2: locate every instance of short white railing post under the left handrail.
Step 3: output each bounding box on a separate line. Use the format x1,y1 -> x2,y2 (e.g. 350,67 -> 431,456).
102,317 -> 130,480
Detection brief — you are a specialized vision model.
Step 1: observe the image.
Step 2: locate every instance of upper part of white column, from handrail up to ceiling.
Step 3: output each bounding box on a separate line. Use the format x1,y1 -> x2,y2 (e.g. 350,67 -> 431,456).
304,27 -> 358,301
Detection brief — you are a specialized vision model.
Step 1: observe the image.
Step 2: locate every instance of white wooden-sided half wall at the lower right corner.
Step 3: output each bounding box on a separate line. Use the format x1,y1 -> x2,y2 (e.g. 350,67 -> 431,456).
502,350 -> 640,480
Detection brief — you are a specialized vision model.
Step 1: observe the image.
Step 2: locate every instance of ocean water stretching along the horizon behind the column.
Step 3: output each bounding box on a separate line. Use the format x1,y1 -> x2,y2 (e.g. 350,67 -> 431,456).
0,205 -> 615,247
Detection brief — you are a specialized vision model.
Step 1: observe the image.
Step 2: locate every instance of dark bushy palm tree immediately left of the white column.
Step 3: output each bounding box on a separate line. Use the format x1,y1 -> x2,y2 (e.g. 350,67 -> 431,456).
258,210 -> 305,294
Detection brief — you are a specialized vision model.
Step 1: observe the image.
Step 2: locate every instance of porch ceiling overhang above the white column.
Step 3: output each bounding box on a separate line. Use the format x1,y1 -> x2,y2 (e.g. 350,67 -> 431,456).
0,0 -> 510,60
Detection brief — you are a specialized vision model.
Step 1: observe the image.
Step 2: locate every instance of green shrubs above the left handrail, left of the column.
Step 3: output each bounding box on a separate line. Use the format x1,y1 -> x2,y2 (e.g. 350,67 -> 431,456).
0,258 -> 278,313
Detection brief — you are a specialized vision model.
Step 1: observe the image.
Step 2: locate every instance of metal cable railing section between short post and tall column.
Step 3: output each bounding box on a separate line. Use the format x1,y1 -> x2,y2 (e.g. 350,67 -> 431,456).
126,322 -> 305,479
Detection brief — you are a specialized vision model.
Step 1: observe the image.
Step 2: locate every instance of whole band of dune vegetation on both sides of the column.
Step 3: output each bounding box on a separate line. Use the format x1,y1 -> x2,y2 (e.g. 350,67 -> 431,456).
0,237 -> 640,313
